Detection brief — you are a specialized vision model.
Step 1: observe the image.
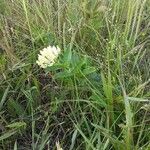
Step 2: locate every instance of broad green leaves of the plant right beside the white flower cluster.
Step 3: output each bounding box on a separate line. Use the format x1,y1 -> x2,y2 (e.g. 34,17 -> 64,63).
47,50 -> 96,82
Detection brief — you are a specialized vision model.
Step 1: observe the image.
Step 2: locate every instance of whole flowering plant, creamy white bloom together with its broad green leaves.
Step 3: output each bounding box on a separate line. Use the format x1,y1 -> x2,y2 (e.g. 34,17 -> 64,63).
36,46 -> 96,81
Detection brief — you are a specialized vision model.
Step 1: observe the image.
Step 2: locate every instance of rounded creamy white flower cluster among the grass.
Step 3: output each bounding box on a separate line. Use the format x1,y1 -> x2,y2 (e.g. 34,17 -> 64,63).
36,46 -> 61,68
